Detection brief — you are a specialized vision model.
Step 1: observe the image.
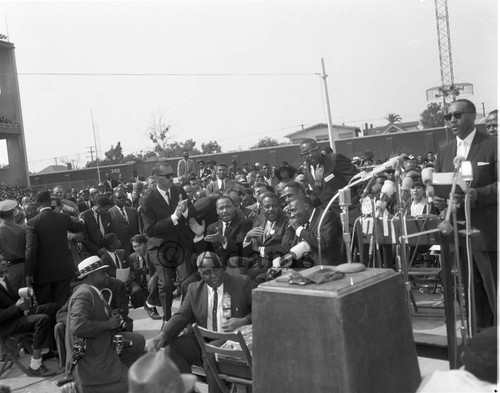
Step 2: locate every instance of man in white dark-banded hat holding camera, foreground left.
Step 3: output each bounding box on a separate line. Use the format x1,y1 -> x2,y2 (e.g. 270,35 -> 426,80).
66,256 -> 145,393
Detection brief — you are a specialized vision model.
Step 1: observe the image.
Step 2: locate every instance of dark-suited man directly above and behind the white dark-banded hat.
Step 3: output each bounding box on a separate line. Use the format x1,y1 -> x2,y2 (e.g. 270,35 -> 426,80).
80,195 -> 113,256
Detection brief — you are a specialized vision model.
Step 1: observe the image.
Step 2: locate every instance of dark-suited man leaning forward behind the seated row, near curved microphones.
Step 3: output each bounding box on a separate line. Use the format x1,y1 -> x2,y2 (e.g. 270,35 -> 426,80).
299,139 -> 361,224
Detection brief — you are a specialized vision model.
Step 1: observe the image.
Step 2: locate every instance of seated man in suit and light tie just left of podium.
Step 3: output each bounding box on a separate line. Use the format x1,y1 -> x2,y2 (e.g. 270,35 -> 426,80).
147,252 -> 254,393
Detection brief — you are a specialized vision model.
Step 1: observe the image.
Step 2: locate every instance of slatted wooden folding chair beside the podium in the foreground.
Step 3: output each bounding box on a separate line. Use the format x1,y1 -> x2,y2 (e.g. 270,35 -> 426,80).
193,323 -> 252,393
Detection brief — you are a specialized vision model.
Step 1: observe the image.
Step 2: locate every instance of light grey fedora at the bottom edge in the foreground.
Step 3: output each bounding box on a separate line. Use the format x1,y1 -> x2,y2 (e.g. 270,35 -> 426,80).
128,351 -> 196,393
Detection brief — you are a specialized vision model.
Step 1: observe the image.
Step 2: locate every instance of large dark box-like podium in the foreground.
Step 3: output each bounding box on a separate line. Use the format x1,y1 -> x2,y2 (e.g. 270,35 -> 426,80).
252,266 -> 421,393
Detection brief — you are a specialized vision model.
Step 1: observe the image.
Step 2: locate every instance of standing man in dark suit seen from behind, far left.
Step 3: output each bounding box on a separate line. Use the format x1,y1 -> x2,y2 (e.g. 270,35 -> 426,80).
25,191 -> 84,307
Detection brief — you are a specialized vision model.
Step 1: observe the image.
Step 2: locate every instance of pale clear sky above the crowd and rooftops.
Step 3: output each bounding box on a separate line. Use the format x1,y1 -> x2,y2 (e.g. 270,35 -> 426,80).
0,0 -> 498,172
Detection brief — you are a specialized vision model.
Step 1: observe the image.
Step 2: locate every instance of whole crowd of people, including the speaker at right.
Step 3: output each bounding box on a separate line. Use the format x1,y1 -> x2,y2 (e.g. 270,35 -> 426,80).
0,100 -> 497,392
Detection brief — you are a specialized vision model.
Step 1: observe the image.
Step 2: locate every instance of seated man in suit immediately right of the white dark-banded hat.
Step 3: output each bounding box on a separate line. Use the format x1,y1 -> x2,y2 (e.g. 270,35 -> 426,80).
101,233 -> 148,308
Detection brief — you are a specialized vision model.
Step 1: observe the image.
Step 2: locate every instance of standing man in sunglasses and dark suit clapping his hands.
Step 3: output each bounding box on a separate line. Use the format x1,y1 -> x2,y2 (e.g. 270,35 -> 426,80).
141,162 -> 196,320
